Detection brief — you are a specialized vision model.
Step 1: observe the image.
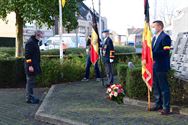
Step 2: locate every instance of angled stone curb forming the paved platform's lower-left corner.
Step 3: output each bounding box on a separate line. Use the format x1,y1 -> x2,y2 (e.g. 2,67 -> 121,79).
35,85 -> 87,125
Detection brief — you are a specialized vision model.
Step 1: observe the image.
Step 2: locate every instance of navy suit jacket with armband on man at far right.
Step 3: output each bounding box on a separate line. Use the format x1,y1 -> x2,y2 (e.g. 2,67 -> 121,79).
152,31 -> 171,72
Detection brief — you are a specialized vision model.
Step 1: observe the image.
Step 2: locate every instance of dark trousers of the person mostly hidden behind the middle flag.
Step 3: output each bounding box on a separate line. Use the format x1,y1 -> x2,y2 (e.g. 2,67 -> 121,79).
85,56 -> 100,79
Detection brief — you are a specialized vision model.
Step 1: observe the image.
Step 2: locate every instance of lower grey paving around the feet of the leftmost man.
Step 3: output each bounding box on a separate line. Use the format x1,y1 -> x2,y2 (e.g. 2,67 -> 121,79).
0,89 -> 49,125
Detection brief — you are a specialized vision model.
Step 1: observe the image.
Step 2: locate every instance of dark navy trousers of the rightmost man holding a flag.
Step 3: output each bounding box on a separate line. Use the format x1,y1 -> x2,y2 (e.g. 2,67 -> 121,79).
153,70 -> 170,111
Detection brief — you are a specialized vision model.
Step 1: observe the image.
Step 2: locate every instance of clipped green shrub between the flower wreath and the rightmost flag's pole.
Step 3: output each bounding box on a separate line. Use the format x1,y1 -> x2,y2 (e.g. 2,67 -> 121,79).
126,67 -> 147,99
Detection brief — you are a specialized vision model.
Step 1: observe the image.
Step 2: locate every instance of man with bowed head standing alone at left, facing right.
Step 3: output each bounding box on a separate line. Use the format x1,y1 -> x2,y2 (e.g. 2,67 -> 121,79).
25,30 -> 43,104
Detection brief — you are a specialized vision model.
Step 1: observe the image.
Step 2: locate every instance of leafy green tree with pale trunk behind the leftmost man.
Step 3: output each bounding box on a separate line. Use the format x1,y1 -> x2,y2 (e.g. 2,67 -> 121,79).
0,0 -> 82,57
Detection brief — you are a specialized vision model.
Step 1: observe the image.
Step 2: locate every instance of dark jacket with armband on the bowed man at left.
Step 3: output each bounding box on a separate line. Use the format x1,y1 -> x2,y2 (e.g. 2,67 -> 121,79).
25,36 -> 41,75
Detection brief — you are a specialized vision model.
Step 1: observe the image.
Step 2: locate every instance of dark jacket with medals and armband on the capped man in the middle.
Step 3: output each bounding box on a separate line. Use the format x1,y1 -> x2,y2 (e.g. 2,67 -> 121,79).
102,37 -> 115,63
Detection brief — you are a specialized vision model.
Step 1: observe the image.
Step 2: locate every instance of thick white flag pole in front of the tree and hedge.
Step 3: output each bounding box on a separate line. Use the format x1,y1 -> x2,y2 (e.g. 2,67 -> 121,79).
59,0 -> 63,62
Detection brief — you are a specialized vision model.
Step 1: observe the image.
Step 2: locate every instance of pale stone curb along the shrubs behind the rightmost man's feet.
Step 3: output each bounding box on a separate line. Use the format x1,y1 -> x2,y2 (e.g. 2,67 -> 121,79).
123,97 -> 188,115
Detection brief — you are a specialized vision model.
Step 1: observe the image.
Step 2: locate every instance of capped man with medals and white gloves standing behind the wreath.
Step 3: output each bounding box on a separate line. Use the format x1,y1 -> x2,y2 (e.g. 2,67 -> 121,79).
102,30 -> 115,87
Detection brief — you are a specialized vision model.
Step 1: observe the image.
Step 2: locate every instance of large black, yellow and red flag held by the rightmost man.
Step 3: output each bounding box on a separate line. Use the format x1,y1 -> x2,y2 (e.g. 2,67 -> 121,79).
142,0 -> 153,91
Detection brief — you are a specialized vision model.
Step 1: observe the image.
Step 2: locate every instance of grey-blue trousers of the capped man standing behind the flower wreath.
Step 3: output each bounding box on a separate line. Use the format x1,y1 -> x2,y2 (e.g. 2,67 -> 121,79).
104,62 -> 114,84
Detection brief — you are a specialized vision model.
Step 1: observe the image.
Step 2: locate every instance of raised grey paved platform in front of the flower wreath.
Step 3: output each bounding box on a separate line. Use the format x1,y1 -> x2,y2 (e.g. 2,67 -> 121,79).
36,81 -> 188,125
